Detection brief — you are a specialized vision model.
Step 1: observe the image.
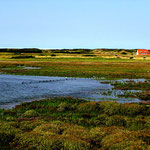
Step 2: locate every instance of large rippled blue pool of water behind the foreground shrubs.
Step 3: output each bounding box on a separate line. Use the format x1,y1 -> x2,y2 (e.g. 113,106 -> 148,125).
0,74 -> 139,108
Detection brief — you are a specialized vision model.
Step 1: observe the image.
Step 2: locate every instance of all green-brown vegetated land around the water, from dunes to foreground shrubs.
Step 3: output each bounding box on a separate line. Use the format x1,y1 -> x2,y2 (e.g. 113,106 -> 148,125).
0,49 -> 150,150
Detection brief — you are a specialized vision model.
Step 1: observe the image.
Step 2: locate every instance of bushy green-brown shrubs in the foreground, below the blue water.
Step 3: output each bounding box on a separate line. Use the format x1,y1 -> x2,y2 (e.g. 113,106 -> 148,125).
0,97 -> 150,150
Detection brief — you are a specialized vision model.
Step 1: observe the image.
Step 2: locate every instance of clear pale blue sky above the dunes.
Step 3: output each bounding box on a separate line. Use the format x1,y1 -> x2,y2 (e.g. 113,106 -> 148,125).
0,0 -> 150,49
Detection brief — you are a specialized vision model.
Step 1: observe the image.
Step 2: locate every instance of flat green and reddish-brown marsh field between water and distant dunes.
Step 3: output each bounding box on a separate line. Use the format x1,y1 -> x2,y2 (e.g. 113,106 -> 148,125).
0,56 -> 150,78
